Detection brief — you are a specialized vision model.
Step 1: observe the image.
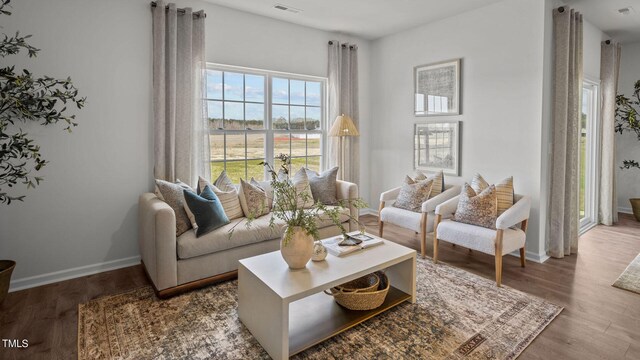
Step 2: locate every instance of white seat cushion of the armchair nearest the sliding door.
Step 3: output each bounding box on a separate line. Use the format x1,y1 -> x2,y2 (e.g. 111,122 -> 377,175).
438,220 -> 525,255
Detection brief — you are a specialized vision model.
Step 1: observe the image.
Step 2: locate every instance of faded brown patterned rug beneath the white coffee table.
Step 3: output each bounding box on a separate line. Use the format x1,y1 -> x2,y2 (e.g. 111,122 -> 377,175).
78,259 -> 562,360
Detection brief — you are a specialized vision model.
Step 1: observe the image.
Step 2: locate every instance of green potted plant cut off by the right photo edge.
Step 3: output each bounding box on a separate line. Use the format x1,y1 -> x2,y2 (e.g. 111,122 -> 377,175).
615,80 -> 640,221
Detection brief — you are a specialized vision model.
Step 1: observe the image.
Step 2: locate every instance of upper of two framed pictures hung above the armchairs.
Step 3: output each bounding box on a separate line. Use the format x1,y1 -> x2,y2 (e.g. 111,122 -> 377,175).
413,59 -> 462,116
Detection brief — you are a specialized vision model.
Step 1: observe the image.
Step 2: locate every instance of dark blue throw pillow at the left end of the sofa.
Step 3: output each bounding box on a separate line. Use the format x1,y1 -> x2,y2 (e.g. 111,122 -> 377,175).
184,185 -> 230,237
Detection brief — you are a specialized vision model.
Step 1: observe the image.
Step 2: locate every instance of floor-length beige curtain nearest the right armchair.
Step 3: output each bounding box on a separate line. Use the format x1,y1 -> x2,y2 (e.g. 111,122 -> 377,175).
547,7 -> 583,258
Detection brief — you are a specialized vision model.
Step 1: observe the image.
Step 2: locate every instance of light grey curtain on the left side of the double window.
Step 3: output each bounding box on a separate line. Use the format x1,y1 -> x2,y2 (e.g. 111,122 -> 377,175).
152,0 -> 211,185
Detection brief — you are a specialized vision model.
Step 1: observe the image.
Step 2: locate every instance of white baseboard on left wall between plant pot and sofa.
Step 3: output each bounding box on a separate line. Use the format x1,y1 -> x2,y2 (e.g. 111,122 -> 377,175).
9,256 -> 140,292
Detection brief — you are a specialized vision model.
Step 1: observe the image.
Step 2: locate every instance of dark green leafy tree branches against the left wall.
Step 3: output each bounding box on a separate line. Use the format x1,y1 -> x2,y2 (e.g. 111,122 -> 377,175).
0,0 -> 86,205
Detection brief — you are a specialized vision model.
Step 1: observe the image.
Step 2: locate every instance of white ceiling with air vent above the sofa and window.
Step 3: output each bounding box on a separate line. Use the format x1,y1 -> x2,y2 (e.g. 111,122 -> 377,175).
206,0 -> 504,40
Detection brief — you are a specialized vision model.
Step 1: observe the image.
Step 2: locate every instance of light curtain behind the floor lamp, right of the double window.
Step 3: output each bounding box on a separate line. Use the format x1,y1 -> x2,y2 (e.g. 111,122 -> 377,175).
326,40 -> 360,184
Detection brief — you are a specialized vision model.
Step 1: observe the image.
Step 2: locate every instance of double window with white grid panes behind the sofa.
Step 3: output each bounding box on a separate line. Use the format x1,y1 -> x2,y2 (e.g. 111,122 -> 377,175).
206,64 -> 326,182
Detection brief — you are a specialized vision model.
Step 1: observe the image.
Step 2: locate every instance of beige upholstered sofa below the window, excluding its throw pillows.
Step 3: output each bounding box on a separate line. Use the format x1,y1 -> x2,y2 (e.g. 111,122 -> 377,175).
138,180 -> 358,297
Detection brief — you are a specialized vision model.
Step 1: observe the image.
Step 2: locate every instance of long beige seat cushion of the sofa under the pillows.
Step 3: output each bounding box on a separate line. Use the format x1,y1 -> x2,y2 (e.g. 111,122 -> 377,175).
177,208 -> 349,259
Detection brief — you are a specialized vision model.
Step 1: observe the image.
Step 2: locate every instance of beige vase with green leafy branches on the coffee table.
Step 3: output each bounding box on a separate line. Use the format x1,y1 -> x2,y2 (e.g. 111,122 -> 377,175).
247,154 -> 367,269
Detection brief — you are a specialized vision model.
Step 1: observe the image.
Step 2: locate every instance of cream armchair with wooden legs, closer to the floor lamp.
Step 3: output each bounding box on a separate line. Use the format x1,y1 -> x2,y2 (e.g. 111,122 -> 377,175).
378,185 -> 460,258
